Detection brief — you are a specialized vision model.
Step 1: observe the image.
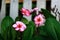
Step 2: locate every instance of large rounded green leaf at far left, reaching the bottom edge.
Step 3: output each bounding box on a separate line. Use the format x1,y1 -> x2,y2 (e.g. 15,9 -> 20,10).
1,16 -> 14,40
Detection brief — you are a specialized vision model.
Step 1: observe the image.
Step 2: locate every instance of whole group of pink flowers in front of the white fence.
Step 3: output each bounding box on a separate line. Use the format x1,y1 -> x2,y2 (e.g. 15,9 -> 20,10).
13,8 -> 45,32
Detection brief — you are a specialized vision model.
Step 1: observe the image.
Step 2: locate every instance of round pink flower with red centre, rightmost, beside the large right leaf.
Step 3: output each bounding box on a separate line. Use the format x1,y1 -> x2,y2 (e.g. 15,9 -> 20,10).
34,14 -> 45,27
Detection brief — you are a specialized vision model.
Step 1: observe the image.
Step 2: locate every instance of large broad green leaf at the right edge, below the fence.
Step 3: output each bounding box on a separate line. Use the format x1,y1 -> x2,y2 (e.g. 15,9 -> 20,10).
44,18 -> 60,40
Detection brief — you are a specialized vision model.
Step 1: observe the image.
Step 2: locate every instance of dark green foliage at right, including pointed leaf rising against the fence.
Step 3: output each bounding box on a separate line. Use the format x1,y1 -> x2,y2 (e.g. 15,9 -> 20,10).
42,9 -> 60,40
